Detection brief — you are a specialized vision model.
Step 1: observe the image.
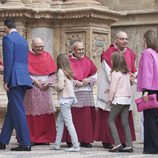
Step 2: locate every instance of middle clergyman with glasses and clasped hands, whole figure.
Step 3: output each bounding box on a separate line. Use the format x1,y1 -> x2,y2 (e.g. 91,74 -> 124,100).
63,41 -> 97,148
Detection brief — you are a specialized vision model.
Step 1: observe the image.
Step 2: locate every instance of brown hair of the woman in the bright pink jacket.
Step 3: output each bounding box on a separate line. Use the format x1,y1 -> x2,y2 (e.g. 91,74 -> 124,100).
144,30 -> 158,53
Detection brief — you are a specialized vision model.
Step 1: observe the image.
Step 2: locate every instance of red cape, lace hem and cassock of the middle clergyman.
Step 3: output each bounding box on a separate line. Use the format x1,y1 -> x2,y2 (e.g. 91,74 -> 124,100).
62,56 -> 97,143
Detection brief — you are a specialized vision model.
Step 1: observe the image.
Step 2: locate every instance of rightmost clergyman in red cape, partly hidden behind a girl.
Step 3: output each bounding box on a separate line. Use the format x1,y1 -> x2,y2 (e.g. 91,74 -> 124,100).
95,31 -> 136,149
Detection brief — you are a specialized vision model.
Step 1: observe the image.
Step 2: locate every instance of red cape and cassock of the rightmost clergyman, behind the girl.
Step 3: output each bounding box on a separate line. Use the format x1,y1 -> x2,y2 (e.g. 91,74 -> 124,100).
94,44 -> 136,144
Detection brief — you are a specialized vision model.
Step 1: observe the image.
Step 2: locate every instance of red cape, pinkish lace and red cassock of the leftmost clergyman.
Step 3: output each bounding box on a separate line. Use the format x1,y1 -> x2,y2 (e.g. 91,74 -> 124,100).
24,51 -> 56,143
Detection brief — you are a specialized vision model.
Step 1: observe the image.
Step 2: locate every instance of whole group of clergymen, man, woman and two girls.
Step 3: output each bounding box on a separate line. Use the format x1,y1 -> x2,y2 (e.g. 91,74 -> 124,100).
0,18 -> 158,154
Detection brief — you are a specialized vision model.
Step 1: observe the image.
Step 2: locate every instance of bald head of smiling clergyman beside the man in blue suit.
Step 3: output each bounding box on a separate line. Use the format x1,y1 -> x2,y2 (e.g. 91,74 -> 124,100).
32,37 -> 44,54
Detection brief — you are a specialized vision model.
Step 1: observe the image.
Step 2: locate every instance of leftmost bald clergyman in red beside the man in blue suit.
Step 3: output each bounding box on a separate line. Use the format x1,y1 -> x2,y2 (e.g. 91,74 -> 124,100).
24,38 -> 56,145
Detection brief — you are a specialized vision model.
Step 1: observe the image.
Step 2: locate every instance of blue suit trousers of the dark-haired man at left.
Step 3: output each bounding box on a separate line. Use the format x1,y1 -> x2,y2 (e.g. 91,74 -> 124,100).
0,86 -> 31,146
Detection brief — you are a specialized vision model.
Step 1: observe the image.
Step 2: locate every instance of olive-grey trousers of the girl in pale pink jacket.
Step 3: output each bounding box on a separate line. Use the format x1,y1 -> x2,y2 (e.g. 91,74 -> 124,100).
108,104 -> 132,147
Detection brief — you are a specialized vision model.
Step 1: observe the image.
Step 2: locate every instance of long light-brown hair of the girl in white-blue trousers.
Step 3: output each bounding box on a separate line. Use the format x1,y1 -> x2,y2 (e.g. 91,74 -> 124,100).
57,54 -> 73,80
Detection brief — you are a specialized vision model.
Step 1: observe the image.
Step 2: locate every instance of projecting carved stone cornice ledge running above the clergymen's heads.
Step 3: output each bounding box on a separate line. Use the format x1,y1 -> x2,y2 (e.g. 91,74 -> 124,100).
0,5 -> 125,23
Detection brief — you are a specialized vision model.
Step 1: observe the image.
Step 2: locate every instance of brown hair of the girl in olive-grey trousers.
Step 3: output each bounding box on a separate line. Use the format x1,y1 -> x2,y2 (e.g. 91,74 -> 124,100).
111,52 -> 129,74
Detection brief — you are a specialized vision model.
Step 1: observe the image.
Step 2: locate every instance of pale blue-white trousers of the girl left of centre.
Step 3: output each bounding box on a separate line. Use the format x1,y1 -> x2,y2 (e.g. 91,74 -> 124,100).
55,103 -> 79,148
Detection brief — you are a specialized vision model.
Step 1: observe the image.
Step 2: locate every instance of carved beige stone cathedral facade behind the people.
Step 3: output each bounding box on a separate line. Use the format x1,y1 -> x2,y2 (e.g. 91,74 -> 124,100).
0,0 -> 158,140
